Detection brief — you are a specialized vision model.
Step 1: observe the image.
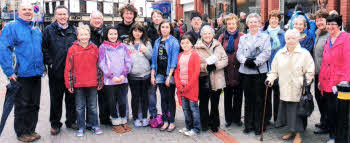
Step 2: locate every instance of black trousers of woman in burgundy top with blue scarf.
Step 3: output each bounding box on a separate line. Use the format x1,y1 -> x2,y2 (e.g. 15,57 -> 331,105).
224,86 -> 243,123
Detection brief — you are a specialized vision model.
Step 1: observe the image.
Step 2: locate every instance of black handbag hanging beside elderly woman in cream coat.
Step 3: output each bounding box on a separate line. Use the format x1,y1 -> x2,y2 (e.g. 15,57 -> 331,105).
297,75 -> 314,117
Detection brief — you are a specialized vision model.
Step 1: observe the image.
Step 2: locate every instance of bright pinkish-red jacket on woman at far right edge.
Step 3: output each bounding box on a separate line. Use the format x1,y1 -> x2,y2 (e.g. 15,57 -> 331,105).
319,32 -> 350,92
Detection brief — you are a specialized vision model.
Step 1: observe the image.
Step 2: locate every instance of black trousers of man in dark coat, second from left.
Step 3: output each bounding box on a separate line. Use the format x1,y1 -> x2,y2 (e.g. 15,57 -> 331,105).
49,69 -> 77,129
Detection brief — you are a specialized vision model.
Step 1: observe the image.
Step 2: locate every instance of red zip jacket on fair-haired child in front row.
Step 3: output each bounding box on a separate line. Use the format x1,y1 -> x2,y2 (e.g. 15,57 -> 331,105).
64,41 -> 103,89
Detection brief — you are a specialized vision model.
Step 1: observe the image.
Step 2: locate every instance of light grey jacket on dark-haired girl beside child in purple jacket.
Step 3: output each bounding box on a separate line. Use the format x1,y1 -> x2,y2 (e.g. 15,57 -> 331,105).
127,42 -> 152,78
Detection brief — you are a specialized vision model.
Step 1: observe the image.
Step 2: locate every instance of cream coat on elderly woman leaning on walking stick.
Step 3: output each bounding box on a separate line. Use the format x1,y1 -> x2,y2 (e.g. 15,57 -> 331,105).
267,45 -> 315,102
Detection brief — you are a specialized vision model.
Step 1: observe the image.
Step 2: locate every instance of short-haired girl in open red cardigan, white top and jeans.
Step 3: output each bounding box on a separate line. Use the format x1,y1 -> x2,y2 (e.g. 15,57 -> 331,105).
174,35 -> 201,136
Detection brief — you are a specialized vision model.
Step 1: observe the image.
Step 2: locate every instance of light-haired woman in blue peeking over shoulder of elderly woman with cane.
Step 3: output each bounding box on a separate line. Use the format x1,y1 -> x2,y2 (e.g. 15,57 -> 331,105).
292,15 -> 314,53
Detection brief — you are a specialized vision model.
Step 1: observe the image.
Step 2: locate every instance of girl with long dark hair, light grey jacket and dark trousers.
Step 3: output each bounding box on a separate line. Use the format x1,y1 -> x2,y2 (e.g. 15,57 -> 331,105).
127,22 -> 152,127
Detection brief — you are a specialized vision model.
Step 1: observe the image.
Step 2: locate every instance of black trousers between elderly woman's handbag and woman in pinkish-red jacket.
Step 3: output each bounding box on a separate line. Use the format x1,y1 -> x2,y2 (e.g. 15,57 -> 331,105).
315,75 -> 327,126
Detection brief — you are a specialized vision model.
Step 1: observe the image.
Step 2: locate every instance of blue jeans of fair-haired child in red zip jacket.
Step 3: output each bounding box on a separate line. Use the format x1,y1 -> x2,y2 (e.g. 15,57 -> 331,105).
74,87 -> 98,129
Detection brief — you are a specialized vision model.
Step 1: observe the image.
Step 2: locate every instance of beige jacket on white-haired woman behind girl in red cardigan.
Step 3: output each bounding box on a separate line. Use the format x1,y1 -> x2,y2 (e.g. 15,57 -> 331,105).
194,39 -> 228,91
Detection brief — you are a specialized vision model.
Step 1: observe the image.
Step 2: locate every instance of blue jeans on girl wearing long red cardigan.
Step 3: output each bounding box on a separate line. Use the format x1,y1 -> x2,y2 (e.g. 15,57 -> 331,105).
181,97 -> 201,134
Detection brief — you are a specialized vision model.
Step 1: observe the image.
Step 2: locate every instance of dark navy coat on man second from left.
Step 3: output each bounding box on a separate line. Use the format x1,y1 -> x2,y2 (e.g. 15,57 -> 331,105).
42,22 -> 77,78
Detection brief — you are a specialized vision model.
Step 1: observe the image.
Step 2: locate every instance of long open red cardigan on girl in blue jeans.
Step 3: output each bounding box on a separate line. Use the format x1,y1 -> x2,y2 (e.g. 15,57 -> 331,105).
174,50 -> 201,105
